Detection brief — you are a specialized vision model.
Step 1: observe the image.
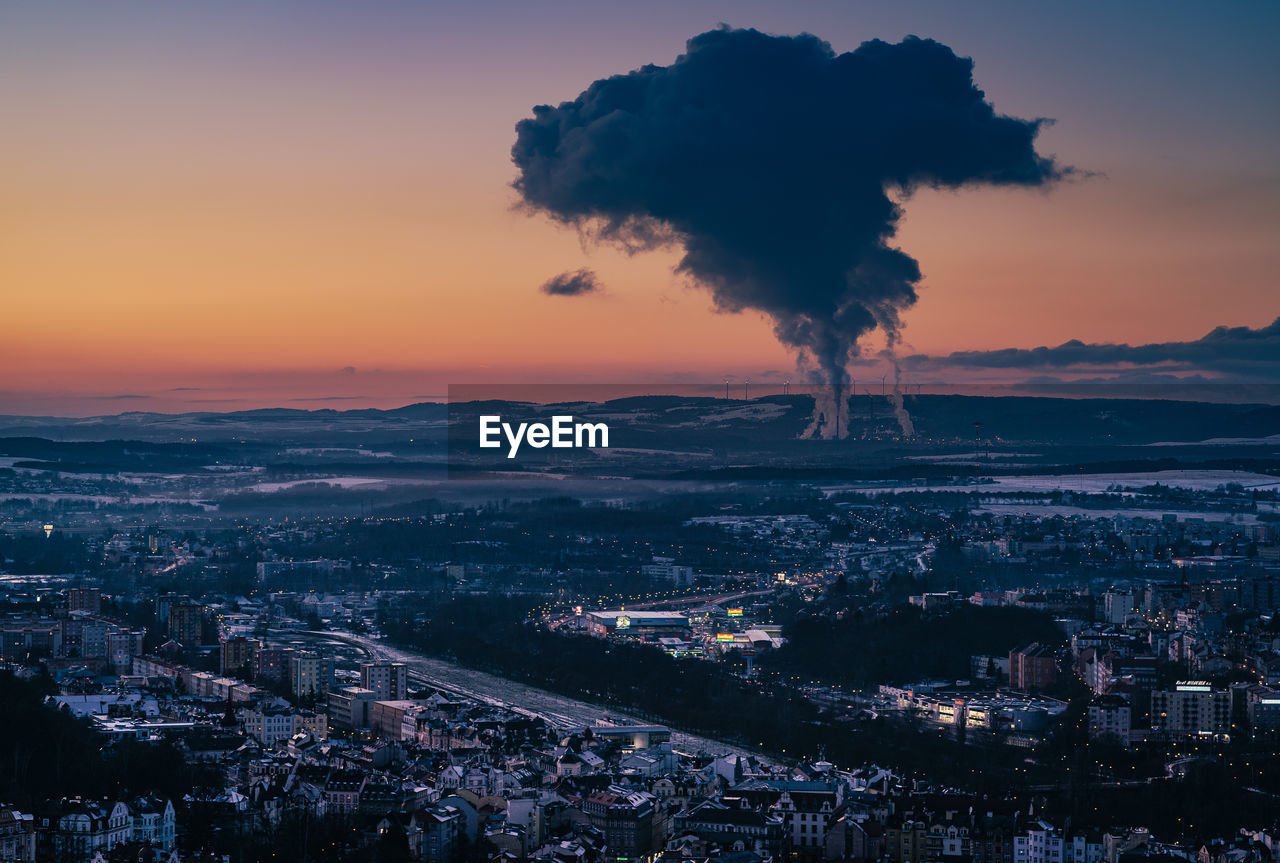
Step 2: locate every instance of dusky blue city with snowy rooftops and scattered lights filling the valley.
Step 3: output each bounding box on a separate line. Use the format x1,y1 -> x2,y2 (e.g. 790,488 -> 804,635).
0,404 -> 1280,863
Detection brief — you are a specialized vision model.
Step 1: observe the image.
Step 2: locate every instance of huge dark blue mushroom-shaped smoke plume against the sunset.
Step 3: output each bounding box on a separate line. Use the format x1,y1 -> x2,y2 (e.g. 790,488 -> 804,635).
512,27 -> 1069,391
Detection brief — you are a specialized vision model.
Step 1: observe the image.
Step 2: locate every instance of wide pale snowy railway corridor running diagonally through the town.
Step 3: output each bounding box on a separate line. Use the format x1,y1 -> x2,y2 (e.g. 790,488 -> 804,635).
290,630 -> 760,758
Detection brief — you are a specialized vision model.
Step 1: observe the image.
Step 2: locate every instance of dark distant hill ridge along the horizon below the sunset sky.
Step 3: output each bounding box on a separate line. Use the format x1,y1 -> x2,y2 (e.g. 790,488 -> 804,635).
0,394 -> 1280,449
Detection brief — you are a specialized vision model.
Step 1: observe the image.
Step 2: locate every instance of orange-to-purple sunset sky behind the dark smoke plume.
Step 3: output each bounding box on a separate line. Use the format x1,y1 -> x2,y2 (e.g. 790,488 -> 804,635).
0,0 -> 1280,415
